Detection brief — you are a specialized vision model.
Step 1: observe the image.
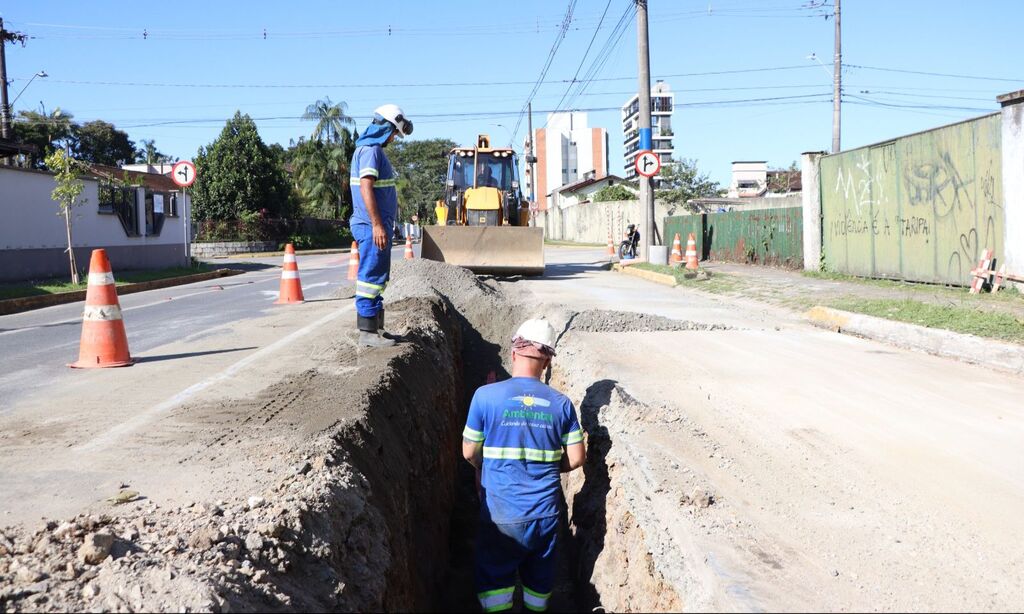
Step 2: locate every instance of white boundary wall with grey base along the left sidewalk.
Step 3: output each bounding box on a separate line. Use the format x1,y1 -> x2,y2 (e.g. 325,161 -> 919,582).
0,167 -> 189,281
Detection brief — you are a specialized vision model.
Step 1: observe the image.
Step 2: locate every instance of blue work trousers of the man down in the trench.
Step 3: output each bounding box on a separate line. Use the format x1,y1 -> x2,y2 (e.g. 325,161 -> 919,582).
476,512 -> 558,612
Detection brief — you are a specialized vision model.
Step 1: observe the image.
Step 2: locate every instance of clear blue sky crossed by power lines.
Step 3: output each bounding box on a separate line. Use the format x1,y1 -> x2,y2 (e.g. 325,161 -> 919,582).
0,0 -> 1024,183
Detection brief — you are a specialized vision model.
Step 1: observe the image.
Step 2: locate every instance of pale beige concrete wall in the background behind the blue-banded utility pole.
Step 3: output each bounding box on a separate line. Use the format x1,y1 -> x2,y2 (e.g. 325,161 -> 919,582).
538,201 -> 683,246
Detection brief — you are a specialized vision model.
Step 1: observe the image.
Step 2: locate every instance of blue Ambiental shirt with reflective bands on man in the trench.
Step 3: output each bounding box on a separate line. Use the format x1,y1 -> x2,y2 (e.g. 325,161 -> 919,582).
462,378 -> 583,524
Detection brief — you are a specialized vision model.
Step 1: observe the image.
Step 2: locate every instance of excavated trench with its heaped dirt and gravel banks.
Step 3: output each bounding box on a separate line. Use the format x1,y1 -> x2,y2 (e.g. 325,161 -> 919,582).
0,260 -> 716,612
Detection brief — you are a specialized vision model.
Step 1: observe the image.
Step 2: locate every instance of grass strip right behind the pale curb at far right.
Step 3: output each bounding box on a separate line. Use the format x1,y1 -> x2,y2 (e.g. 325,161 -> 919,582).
828,299 -> 1024,344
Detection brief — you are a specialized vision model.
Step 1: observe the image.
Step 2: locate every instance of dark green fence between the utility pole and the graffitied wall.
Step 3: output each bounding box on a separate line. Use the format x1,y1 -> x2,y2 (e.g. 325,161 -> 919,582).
665,207 -> 804,268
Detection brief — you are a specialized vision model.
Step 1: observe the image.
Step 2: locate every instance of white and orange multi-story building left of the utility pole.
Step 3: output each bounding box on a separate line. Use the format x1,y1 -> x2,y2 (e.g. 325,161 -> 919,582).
523,113 -> 608,211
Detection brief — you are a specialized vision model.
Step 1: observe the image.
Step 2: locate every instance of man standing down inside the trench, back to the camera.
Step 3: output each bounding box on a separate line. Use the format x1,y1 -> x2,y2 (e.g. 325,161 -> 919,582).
462,319 -> 587,612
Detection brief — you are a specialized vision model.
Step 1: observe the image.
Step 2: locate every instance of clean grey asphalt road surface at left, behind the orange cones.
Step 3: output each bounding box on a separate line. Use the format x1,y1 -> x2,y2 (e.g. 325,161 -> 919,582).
0,246 -> 407,413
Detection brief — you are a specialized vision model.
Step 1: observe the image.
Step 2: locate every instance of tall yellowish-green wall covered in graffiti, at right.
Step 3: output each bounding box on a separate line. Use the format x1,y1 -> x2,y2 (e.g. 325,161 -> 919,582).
820,114 -> 1004,284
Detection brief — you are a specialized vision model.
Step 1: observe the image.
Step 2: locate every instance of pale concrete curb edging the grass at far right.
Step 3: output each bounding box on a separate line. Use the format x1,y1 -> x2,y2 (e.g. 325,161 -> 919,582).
804,305 -> 1024,375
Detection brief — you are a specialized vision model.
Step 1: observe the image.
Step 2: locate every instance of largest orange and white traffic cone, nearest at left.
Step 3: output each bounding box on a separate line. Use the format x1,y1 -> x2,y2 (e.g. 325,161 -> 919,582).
68,250 -> 135,368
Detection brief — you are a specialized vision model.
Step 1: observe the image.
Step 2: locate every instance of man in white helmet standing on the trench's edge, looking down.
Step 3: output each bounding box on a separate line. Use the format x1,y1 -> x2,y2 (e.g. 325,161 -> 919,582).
348,104 -> 413,348
